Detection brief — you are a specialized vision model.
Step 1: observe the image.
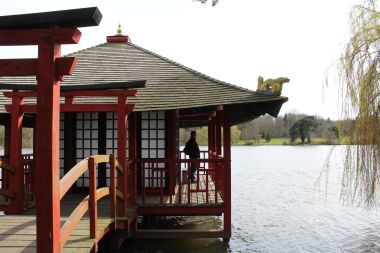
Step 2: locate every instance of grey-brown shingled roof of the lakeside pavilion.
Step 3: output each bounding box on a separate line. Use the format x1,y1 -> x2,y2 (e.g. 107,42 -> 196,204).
0,43 -> 287,123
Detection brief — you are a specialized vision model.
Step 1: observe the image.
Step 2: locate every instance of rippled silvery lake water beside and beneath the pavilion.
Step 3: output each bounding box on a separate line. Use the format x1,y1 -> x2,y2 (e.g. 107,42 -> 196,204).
121,146 -> 380,253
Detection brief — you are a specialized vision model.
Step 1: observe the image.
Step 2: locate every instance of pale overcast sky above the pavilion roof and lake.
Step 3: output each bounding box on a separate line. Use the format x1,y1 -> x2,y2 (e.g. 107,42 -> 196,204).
0,0 -> 361,118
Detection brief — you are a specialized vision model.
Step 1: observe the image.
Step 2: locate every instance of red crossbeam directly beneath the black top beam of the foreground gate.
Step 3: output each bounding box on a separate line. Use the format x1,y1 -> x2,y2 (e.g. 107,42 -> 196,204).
0,28 -> 82,45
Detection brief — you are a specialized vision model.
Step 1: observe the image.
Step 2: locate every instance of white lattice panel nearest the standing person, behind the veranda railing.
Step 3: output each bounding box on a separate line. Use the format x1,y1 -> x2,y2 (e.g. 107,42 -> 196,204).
140,111 -> 166,188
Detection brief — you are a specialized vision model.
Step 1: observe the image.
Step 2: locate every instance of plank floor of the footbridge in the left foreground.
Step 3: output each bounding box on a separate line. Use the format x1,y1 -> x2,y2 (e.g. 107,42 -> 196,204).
0,195 -> 136,253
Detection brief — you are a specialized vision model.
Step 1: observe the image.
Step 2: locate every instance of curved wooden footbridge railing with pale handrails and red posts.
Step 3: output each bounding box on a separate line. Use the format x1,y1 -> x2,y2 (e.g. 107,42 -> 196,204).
60,155 -> 126,248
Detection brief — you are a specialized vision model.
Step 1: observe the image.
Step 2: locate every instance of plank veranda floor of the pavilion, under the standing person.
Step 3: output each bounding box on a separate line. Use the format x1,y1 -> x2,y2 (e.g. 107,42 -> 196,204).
137,175 -> 223,207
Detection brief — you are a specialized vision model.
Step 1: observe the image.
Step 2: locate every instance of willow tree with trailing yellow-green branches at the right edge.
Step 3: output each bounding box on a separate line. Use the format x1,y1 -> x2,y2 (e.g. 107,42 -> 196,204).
340,0 -> 380,207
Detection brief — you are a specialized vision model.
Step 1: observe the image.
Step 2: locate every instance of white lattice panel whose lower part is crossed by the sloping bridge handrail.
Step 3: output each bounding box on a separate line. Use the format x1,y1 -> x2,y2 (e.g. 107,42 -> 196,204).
75,112 -> 99,187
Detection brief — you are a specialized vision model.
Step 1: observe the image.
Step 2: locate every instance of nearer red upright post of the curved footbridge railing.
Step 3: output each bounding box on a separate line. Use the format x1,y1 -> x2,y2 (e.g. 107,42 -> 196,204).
88,157 -> 98,239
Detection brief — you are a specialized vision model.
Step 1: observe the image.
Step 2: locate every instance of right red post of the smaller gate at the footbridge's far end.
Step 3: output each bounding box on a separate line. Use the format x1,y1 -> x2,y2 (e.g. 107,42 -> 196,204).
117,95 -> 128,216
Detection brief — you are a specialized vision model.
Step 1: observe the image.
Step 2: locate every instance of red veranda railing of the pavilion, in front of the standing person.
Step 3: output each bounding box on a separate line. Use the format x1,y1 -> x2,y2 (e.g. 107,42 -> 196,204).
137,151 -> 224,205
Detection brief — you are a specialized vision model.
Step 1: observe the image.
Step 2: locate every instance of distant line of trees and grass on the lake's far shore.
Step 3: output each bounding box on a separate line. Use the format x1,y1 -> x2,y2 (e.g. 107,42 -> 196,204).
179,113 -> 346,145
